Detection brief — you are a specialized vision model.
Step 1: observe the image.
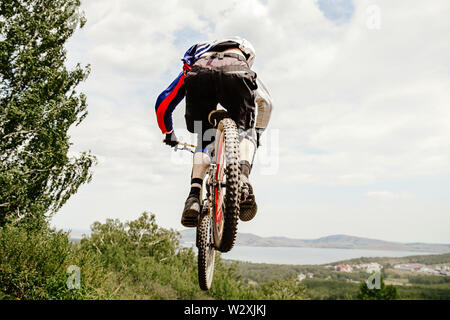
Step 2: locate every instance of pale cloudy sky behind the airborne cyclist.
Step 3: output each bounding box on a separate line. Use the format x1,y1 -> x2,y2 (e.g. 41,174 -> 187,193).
53,0 -> 450,243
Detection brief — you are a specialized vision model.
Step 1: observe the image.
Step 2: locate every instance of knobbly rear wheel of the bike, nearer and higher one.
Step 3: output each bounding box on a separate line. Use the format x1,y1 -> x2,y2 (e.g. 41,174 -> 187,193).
213,118 -> 239,252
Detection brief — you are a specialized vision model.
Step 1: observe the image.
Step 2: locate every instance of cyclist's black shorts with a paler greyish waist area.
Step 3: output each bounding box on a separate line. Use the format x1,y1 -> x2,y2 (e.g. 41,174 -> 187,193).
184,56 -> 257,148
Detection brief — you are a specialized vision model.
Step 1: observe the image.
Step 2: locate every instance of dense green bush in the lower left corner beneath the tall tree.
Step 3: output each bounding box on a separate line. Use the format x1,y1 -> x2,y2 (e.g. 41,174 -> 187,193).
0,225 -> 100,299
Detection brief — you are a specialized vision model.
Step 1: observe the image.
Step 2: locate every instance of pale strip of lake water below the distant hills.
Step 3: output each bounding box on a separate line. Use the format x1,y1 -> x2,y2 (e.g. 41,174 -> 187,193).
184,243 -> 436,265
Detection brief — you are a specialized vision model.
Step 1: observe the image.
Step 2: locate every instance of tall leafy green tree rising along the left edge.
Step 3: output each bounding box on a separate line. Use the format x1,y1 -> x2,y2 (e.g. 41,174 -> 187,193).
0,0 -> 96,226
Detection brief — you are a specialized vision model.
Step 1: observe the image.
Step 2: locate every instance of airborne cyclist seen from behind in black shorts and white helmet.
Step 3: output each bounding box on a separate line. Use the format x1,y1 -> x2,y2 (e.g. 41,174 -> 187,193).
155,37 -> 272,227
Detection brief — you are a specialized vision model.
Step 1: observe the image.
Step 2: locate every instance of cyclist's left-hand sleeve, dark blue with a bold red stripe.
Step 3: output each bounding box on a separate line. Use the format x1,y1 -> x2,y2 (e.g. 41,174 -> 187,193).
155,72 -> 185,133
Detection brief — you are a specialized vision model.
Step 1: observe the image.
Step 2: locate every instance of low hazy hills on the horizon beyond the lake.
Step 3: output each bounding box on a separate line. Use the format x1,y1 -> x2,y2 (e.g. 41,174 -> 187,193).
180,229 -> 450,253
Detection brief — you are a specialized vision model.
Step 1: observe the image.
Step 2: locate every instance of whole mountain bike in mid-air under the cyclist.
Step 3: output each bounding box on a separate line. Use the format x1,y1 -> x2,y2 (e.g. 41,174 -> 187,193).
175,110 -> 240,290
